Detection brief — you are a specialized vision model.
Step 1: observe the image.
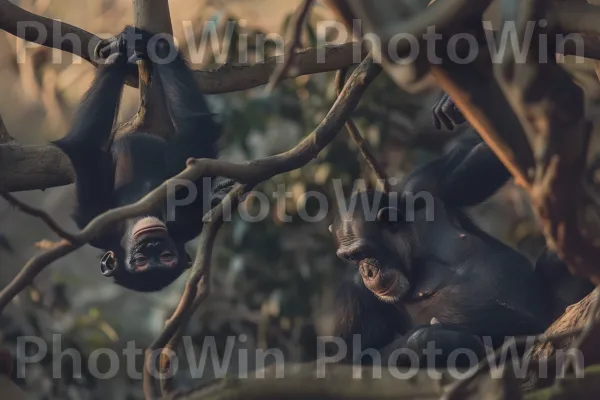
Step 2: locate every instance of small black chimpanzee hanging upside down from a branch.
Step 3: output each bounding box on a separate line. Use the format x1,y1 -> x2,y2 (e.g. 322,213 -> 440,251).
54,27 -> 226,292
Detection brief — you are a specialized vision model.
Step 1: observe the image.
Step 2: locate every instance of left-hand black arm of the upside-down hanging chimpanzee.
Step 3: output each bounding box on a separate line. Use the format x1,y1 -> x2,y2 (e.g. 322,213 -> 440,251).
53,55 -> 127,228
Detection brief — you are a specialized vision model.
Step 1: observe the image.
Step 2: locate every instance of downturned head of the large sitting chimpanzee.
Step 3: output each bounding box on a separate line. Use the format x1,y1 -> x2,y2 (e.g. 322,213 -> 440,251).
330,192 -> 414,302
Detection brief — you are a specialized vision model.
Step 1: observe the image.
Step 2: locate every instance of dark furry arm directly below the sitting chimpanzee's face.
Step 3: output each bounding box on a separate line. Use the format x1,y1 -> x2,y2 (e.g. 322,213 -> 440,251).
334,279 -> 409,363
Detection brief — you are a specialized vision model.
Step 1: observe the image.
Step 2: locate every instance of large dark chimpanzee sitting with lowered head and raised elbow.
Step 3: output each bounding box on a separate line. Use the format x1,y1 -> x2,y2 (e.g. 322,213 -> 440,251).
331,94 -> 593,362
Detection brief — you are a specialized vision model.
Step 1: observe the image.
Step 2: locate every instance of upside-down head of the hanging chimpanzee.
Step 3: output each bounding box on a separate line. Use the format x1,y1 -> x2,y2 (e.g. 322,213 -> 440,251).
100,217 -> 190,292
